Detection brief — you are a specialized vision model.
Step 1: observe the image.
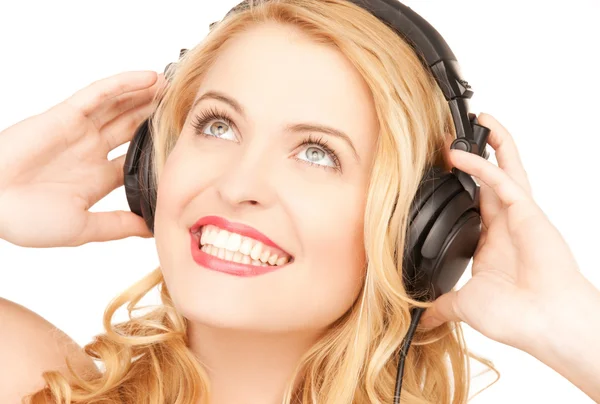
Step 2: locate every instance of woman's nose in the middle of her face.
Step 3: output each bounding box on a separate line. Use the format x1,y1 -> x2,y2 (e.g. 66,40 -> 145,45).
215,142 -> 275,209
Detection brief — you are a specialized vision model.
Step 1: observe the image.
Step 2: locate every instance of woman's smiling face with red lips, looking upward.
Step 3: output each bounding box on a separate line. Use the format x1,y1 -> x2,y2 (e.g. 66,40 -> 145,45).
155,24 -> 378,331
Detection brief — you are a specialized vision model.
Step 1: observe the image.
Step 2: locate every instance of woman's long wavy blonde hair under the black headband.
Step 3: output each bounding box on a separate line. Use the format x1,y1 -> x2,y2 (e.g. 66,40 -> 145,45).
25,0 -> 499,404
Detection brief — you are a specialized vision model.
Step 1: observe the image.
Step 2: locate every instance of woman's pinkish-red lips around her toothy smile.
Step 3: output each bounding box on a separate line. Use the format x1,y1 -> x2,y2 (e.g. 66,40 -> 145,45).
190,216 -> 293,277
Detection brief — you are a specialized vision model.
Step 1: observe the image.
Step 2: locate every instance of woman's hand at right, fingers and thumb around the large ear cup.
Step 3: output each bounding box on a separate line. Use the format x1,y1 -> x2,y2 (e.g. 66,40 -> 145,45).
421,114 -> 587,350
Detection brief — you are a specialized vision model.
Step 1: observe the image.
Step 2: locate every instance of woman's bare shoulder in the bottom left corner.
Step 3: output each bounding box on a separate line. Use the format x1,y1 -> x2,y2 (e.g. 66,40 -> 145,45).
0,298 -> 100,404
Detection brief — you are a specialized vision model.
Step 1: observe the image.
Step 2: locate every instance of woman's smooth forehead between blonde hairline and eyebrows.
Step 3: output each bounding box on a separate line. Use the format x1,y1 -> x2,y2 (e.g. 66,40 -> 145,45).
196,23 -> 377,148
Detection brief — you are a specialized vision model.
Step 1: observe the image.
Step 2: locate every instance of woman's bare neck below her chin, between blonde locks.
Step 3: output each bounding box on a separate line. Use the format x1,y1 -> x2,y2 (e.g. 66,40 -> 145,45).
188,322 -> 319,404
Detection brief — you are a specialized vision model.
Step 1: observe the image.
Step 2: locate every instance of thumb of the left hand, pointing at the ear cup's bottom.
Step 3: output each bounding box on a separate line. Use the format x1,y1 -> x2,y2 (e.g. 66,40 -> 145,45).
81,210 -> 152,243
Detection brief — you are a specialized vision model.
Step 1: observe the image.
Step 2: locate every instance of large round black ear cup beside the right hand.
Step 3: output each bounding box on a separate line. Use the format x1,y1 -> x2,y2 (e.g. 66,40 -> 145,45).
402,167 -> 481,300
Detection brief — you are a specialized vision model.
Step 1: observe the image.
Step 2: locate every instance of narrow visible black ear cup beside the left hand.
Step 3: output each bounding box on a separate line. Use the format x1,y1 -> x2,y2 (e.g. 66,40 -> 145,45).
123,117 -> 156,233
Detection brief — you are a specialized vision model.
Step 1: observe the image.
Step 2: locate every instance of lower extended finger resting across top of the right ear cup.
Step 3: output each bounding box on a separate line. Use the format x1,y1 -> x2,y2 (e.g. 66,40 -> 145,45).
450,150 -> 530,207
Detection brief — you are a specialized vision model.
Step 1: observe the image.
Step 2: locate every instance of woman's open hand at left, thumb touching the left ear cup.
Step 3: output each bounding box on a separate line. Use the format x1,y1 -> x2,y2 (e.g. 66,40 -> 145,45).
0,71 -> 165,248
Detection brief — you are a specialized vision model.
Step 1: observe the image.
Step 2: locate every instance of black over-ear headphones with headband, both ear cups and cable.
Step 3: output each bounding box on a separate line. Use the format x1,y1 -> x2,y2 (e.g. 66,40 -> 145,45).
124,0 -> 490,403
